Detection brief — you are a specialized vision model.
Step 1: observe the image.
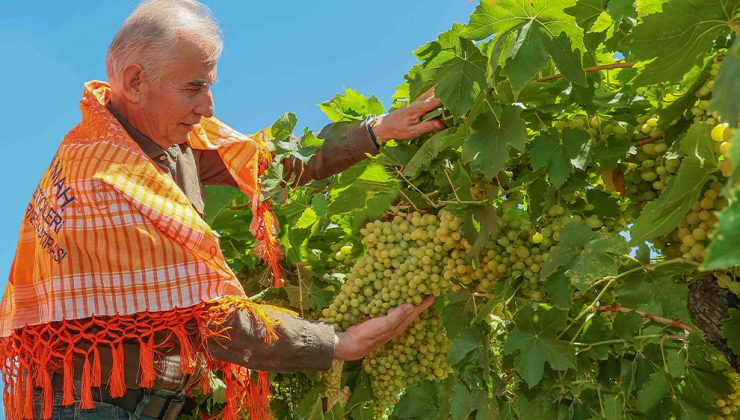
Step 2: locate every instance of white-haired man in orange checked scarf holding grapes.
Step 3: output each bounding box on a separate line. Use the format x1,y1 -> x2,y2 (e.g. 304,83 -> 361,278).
0,0 -> 441,419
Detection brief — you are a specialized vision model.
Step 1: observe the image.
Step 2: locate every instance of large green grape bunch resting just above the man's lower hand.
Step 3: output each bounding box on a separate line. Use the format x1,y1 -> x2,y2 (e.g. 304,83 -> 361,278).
322,212 -> 450,329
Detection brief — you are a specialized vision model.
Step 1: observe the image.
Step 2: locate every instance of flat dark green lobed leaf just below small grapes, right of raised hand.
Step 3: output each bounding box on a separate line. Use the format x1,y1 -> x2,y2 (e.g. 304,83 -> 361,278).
530,128 -> 591,187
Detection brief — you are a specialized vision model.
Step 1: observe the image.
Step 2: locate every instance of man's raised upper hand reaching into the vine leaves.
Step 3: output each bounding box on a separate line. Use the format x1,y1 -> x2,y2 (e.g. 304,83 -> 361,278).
373,90 -> 444,143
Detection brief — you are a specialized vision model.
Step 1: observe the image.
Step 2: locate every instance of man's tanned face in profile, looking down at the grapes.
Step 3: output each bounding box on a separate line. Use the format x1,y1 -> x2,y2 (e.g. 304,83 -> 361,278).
136,38 -> 216,148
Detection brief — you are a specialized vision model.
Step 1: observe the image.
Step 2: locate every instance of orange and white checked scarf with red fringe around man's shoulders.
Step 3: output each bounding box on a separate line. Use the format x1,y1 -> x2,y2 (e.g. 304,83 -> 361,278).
0,81 -> 282,419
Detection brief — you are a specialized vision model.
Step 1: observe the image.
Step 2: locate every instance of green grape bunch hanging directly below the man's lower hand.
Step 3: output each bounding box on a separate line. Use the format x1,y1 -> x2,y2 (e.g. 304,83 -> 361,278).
362,309 -> 452,418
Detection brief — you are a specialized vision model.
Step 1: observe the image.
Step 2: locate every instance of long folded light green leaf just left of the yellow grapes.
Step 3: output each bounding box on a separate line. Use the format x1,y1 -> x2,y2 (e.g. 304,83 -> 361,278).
631,123 -> 716,244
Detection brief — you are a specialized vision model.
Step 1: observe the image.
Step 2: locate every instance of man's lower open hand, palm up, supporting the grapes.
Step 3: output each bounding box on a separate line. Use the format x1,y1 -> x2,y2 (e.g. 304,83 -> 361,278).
334,296 -> 434,360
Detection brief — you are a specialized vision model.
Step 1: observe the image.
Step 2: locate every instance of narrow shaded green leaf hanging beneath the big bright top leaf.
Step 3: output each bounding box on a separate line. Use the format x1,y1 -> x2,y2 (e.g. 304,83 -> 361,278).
502,22 -> 548,93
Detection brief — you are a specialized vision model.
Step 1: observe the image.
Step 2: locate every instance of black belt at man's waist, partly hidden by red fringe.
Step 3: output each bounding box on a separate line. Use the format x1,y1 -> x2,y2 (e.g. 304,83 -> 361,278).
51,373 -> 188,420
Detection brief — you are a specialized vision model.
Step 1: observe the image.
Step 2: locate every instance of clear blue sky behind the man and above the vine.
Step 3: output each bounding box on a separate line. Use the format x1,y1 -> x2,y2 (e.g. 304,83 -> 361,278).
0,0 -> 477,300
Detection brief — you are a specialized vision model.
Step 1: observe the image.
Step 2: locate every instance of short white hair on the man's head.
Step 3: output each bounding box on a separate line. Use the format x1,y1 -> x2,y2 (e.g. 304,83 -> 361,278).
105,0 -> 223,85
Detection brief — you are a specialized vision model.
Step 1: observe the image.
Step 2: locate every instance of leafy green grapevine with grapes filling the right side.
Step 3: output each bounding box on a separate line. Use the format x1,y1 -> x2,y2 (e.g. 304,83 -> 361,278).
192,0 -> 740,419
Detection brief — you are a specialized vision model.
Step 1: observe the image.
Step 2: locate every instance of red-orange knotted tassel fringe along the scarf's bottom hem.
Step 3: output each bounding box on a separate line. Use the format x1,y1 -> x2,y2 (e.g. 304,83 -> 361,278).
0,296 -> 277,420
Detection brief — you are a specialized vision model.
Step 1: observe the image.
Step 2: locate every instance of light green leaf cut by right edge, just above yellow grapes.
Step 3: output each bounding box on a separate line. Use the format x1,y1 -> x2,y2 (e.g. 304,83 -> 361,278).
710,37 -> 740,125
